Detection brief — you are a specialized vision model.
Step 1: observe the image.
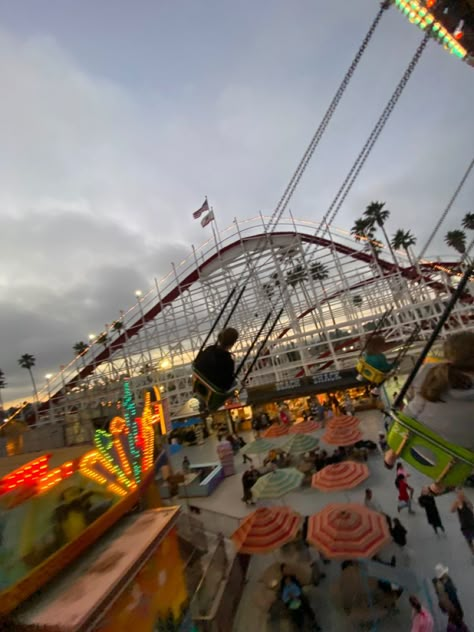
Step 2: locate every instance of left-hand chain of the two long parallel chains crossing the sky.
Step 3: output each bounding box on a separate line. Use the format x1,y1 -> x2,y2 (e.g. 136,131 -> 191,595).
267,0 -> 391,232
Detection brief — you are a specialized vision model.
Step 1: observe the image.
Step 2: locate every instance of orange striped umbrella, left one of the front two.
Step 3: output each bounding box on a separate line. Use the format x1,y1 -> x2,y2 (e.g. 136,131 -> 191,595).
232,507 -> 301,555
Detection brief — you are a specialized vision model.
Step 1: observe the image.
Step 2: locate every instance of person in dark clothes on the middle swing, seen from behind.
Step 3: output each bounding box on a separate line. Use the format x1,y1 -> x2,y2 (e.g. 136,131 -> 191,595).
194,327 -> 239,391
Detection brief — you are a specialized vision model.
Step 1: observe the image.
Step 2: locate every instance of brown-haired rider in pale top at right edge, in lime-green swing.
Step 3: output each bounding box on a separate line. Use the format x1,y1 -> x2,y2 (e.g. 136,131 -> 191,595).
384,331 -> 474,472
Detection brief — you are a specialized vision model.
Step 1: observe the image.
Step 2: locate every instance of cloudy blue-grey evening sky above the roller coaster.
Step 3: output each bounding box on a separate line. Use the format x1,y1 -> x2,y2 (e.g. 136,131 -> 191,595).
0,0 -> 474,399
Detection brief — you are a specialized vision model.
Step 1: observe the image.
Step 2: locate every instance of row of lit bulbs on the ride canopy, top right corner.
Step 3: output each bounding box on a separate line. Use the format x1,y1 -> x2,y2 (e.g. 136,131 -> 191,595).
394,0 -> 474,66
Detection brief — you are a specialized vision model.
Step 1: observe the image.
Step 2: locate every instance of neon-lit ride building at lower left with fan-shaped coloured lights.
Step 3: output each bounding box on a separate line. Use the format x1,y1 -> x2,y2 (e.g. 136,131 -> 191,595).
0,382 -> 187,632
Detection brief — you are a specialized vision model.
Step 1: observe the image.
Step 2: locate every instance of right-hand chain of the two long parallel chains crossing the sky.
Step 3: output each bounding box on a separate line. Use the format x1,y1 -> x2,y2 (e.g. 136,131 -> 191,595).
322,32 -> 431,233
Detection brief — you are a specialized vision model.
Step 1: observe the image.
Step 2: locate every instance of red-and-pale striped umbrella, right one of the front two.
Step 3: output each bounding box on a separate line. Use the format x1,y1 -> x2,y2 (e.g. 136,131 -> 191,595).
307,503 -> 391,560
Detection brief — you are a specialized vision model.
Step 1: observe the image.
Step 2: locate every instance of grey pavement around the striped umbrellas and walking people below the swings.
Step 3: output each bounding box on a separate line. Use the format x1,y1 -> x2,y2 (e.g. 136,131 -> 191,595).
168,411 -> 474,632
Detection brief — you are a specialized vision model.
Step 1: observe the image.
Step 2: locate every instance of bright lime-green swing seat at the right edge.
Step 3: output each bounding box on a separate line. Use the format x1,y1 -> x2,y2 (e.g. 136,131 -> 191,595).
387,411 -> 474,487
